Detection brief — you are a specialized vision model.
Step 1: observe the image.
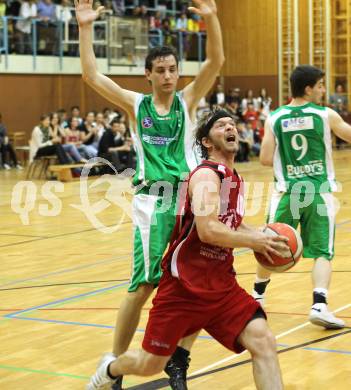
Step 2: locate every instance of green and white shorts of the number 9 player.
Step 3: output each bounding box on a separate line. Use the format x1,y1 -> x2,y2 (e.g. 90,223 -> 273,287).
267,191 -> 336,260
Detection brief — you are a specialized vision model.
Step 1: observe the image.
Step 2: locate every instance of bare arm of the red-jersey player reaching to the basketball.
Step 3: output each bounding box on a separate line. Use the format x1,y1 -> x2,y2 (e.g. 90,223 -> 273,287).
189,169 -> 287,259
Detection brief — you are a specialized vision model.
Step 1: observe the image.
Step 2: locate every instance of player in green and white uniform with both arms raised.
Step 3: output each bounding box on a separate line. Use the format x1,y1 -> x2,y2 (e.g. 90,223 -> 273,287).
75,0 -> 224,390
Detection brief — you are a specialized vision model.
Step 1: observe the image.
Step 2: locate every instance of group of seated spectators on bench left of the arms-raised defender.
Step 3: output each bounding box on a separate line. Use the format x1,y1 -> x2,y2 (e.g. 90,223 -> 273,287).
29,106 -> 136,172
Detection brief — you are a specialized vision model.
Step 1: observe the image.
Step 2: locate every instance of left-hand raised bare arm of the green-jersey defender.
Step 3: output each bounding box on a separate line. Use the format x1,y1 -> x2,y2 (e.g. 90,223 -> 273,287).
74,0 -> 137,120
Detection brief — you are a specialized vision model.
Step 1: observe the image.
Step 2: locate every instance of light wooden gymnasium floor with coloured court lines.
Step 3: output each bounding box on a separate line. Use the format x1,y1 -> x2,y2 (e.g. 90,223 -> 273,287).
0,150 -> 351,390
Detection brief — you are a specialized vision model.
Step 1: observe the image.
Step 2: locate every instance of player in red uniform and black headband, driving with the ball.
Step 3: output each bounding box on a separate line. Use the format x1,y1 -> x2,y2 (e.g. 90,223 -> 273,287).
89,110 -> 287,390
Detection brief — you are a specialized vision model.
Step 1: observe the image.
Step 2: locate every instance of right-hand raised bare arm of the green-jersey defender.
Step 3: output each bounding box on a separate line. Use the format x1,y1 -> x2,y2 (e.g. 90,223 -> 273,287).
184,0 -> 224,115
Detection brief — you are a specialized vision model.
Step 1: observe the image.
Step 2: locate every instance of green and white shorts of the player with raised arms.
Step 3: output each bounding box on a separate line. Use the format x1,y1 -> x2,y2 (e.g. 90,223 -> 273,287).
128,193 -> 176,292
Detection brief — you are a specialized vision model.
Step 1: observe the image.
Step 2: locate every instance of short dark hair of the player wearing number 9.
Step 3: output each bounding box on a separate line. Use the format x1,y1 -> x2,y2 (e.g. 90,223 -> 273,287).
290,65 -> 325,98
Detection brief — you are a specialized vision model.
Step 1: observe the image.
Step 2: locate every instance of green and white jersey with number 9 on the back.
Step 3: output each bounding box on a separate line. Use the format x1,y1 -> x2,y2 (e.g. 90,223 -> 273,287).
269,103 -> 336,193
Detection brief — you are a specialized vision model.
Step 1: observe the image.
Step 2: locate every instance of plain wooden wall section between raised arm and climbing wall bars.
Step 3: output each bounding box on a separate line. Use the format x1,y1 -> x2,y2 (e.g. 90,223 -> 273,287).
217,0 -> 278,106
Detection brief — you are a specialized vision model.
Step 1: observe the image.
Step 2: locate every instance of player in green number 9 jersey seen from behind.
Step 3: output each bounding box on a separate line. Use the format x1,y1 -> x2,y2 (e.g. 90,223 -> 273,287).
253,65 -> 351,329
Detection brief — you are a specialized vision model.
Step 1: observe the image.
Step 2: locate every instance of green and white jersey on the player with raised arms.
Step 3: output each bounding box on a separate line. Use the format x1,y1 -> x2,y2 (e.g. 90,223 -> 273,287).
133,92 -> 198,187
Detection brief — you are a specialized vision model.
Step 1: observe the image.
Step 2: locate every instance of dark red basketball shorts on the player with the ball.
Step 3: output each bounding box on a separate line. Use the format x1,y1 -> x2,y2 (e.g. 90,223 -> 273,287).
143,274 -> 261,356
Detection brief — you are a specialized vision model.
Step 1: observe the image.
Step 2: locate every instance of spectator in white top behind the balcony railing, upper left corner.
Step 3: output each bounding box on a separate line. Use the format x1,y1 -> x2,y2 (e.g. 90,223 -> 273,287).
16,0 -> 37,54
